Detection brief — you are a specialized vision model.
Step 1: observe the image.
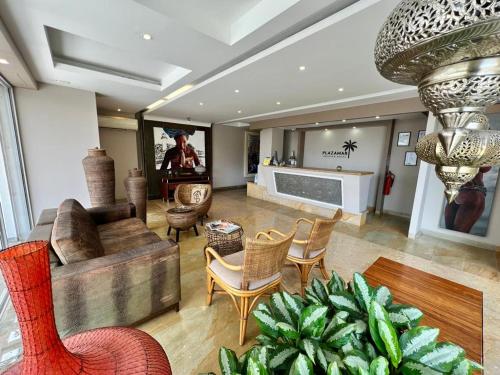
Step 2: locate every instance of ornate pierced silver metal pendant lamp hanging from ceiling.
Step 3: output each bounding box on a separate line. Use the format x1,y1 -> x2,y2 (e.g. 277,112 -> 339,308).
375,0 -> 500,202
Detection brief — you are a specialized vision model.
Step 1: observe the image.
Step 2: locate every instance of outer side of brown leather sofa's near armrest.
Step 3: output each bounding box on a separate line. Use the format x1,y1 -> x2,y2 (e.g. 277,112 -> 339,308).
52,240 -> 180,336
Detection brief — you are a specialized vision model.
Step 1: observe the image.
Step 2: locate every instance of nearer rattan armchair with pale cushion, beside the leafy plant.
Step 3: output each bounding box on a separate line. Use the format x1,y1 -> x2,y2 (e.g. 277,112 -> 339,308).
205,229 -> 295,345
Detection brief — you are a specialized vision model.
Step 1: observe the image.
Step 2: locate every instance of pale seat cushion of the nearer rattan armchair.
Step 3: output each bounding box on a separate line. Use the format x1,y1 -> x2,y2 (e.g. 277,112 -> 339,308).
209,250 -> 281,290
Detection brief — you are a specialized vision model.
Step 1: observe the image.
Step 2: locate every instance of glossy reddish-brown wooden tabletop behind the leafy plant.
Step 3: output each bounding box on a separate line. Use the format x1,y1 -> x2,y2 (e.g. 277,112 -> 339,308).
364,257 -> 483,363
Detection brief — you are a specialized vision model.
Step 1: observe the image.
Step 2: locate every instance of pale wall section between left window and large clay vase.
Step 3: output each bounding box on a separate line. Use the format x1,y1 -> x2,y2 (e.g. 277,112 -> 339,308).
14,84 -> 99,221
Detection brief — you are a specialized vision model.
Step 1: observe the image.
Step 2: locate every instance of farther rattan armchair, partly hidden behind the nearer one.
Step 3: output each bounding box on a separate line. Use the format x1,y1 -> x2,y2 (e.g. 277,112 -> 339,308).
268,208 -> 342,295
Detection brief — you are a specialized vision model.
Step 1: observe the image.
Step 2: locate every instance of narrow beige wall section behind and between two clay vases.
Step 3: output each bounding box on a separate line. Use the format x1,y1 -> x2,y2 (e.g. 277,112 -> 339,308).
99,127 -> 138,199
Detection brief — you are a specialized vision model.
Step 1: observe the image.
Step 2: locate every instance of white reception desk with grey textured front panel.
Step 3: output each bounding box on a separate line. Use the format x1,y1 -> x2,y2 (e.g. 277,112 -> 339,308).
247,165 -> 373,226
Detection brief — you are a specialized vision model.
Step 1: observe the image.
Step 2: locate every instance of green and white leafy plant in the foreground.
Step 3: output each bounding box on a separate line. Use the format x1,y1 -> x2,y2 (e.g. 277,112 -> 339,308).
206,272 -> 481,375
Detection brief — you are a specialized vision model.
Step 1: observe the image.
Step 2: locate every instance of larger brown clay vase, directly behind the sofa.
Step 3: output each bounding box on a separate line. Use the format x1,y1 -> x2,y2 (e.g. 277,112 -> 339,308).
82,148 -> 115,207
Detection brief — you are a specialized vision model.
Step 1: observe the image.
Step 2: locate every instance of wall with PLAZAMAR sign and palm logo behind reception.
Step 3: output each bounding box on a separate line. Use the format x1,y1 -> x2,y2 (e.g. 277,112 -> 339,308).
303,121 -> 389,207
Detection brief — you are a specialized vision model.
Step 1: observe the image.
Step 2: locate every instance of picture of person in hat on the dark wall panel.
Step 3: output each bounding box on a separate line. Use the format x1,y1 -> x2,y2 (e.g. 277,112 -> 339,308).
153,127 -> 206,171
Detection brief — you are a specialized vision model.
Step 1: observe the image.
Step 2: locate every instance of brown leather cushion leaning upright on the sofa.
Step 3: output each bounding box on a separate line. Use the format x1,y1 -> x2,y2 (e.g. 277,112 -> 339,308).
51,199 -> 104,264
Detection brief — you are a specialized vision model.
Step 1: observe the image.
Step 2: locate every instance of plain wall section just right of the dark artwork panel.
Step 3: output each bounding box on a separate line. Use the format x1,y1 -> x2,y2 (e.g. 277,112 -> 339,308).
212,125 -> 247,188
